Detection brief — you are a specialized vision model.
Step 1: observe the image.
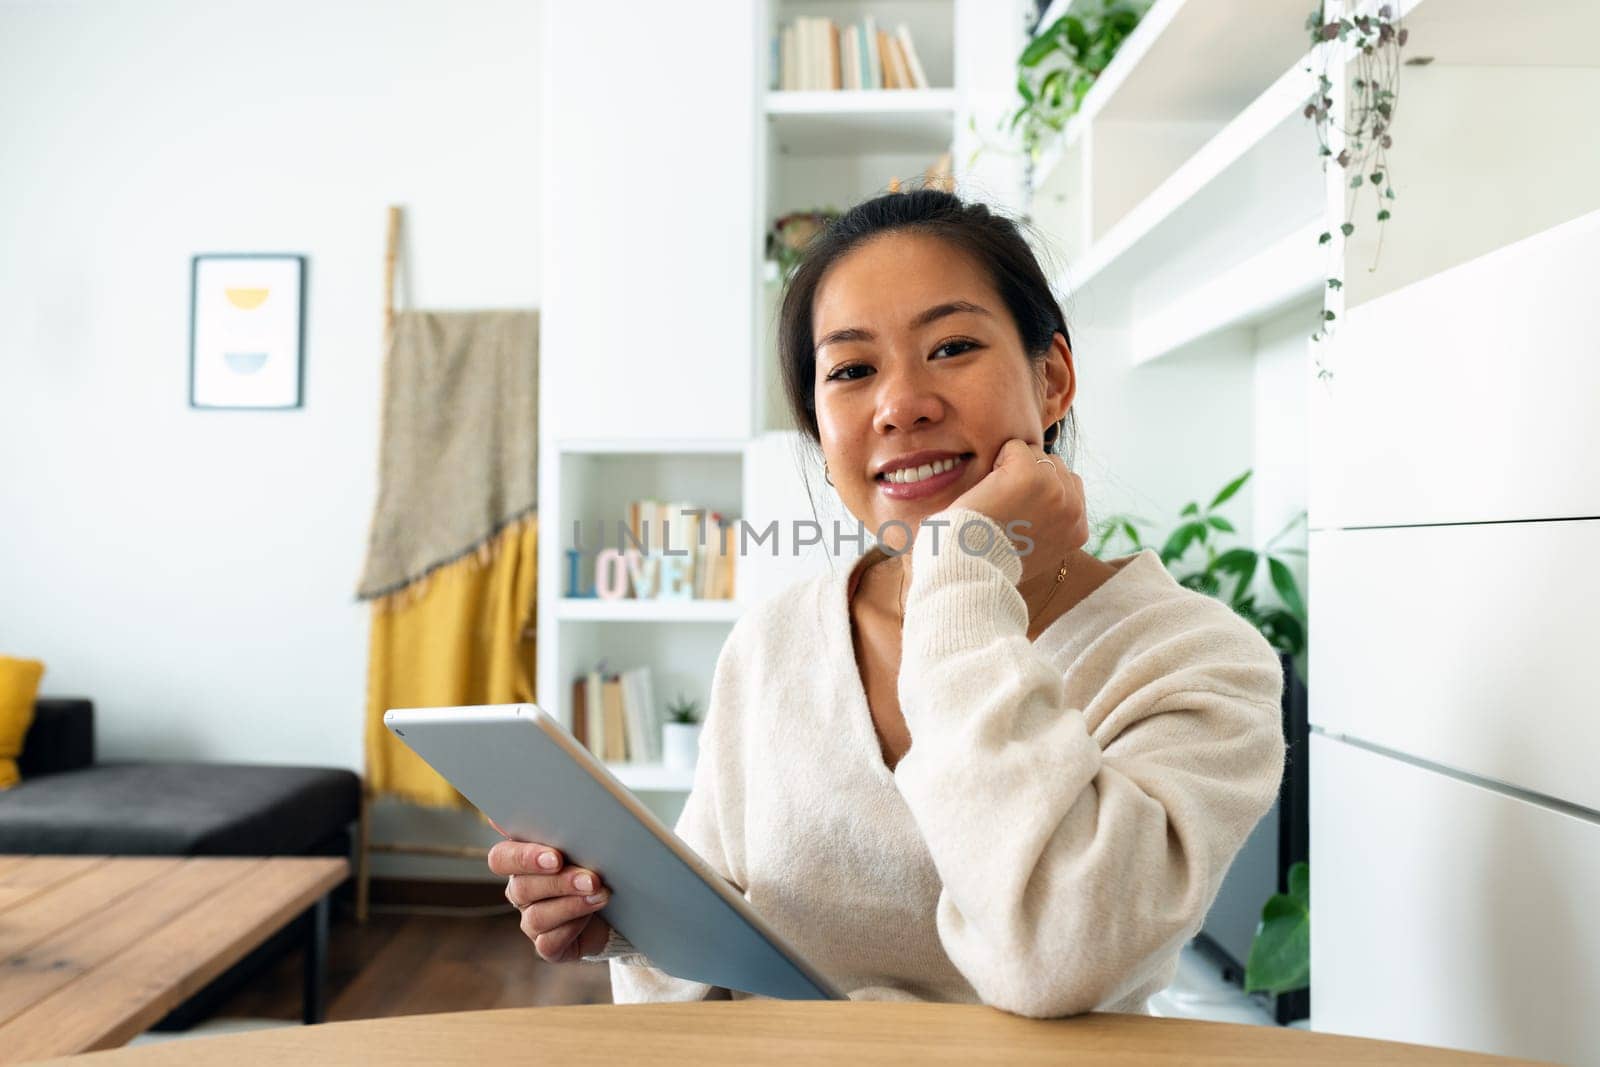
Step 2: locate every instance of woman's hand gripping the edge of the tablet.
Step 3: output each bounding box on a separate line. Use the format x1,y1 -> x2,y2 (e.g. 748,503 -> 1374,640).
490,819 -> 611,963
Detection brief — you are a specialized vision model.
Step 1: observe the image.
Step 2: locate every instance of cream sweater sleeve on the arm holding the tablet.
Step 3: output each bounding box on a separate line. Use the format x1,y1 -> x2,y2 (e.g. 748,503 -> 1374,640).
601,625 -> 744,1005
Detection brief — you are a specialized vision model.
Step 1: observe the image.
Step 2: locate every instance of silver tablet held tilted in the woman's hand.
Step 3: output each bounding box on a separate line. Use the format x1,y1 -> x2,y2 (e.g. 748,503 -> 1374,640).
384,704 -> 848,1000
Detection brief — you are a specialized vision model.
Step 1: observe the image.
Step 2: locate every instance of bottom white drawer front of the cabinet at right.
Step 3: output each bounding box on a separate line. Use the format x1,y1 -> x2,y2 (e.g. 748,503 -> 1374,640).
1310,734 -> 1600,1064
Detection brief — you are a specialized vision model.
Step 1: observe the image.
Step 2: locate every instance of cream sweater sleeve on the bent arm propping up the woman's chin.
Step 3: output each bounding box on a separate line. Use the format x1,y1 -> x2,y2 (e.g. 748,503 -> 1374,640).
894,509 -> 1285,1017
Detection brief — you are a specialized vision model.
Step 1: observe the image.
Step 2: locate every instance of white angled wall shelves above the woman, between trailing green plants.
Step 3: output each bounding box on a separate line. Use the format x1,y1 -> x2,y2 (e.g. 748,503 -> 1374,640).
1034,0 -> 1326,355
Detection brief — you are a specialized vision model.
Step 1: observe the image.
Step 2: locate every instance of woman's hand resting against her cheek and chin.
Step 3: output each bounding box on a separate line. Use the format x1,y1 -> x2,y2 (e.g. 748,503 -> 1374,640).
950,437 -> 1090,579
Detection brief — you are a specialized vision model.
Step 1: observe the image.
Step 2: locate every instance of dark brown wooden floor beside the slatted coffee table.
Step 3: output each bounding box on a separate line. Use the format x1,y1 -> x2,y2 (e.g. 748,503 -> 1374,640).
216,904 -> 611,1022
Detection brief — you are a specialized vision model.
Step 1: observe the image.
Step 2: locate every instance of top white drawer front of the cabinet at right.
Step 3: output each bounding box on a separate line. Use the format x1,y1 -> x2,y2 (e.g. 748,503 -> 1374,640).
1309,213 -> 1600,530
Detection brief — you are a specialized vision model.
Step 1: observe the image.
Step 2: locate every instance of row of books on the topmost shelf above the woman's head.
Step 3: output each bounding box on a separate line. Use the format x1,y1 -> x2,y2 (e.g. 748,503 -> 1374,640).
773,14 -> 928,91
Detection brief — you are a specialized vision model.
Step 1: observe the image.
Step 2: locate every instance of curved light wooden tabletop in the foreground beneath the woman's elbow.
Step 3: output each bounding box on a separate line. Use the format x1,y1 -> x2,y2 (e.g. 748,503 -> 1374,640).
21,1000 -> 1548,1067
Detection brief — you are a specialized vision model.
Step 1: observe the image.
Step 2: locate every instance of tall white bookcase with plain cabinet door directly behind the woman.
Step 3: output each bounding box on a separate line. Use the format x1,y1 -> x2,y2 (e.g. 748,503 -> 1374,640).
538,0 -> 998,819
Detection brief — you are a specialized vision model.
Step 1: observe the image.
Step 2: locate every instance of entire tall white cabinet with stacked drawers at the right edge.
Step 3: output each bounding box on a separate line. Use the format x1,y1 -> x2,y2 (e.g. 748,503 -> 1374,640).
1310,0 -> 1600,1062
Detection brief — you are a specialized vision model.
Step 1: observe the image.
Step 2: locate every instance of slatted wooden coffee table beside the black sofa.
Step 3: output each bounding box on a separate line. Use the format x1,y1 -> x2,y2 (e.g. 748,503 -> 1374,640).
0,856 -> 349,1064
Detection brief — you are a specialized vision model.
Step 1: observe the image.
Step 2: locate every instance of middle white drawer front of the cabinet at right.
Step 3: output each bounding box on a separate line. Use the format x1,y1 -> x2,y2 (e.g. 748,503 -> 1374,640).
1307,522 -> 1600,809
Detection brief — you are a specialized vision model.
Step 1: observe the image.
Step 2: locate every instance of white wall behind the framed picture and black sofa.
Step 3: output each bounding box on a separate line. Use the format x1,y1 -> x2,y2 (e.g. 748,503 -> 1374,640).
0,0 -> 541,790
